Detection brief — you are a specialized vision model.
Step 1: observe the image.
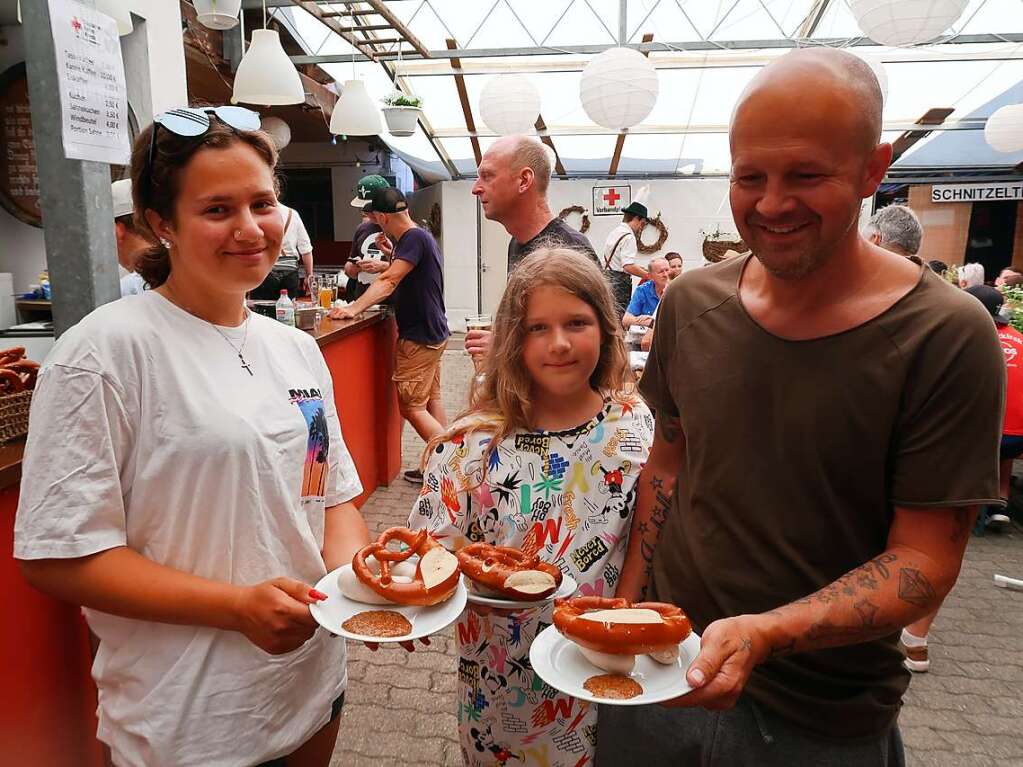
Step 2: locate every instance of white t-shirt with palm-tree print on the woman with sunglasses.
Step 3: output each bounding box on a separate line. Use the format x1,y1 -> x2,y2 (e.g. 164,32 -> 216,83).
14,290 -> 362,767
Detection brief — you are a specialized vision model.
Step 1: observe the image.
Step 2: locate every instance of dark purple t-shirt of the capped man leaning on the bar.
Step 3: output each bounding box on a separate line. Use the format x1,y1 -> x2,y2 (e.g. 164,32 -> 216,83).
393,227 -> 451,346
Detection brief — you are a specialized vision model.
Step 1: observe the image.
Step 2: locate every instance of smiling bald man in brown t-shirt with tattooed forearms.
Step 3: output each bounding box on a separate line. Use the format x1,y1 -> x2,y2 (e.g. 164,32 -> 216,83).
596,48 -> 1005,767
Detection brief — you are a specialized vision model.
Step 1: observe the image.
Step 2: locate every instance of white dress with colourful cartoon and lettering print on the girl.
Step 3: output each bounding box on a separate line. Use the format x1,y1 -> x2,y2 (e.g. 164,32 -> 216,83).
409,399 -> 654,767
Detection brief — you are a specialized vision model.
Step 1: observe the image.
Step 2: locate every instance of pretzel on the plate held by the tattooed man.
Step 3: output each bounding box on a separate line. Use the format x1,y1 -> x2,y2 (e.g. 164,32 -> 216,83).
554,596 -> 692,656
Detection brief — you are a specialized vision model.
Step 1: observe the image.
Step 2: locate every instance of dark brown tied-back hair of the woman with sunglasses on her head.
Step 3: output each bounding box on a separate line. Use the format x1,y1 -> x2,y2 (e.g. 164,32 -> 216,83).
131,115 -> 279,287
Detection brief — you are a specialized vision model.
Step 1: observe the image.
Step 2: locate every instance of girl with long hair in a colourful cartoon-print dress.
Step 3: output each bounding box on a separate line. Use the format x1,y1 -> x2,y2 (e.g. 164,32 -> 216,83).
409,250 -> 654,767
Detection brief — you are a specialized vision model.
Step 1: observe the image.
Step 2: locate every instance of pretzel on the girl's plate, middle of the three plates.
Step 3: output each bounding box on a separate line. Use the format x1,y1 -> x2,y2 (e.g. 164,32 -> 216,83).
457,543 -> 562,600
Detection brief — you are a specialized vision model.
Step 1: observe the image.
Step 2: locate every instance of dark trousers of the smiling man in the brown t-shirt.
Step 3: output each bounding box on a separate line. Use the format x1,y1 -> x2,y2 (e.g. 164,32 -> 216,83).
594,695 -> 905,767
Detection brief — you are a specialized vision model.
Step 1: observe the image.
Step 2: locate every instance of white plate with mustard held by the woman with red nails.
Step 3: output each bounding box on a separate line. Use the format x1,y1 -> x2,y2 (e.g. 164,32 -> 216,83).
309,565 -> 466,643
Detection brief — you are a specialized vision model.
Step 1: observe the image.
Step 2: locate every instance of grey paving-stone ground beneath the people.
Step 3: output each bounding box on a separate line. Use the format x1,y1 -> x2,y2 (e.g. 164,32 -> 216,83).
331,344 -> 1023,767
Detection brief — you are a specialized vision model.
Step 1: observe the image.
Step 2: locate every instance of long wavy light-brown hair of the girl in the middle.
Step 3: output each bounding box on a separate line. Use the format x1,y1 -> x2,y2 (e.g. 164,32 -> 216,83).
424,247 -> 633,474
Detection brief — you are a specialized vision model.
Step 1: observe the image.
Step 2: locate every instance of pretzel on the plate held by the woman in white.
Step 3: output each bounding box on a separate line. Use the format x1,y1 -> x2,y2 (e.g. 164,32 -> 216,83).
352,528 -> 461,606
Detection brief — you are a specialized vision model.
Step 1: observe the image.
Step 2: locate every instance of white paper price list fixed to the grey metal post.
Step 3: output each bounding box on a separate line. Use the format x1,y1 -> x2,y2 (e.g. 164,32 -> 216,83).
48,0 -> 131,165
